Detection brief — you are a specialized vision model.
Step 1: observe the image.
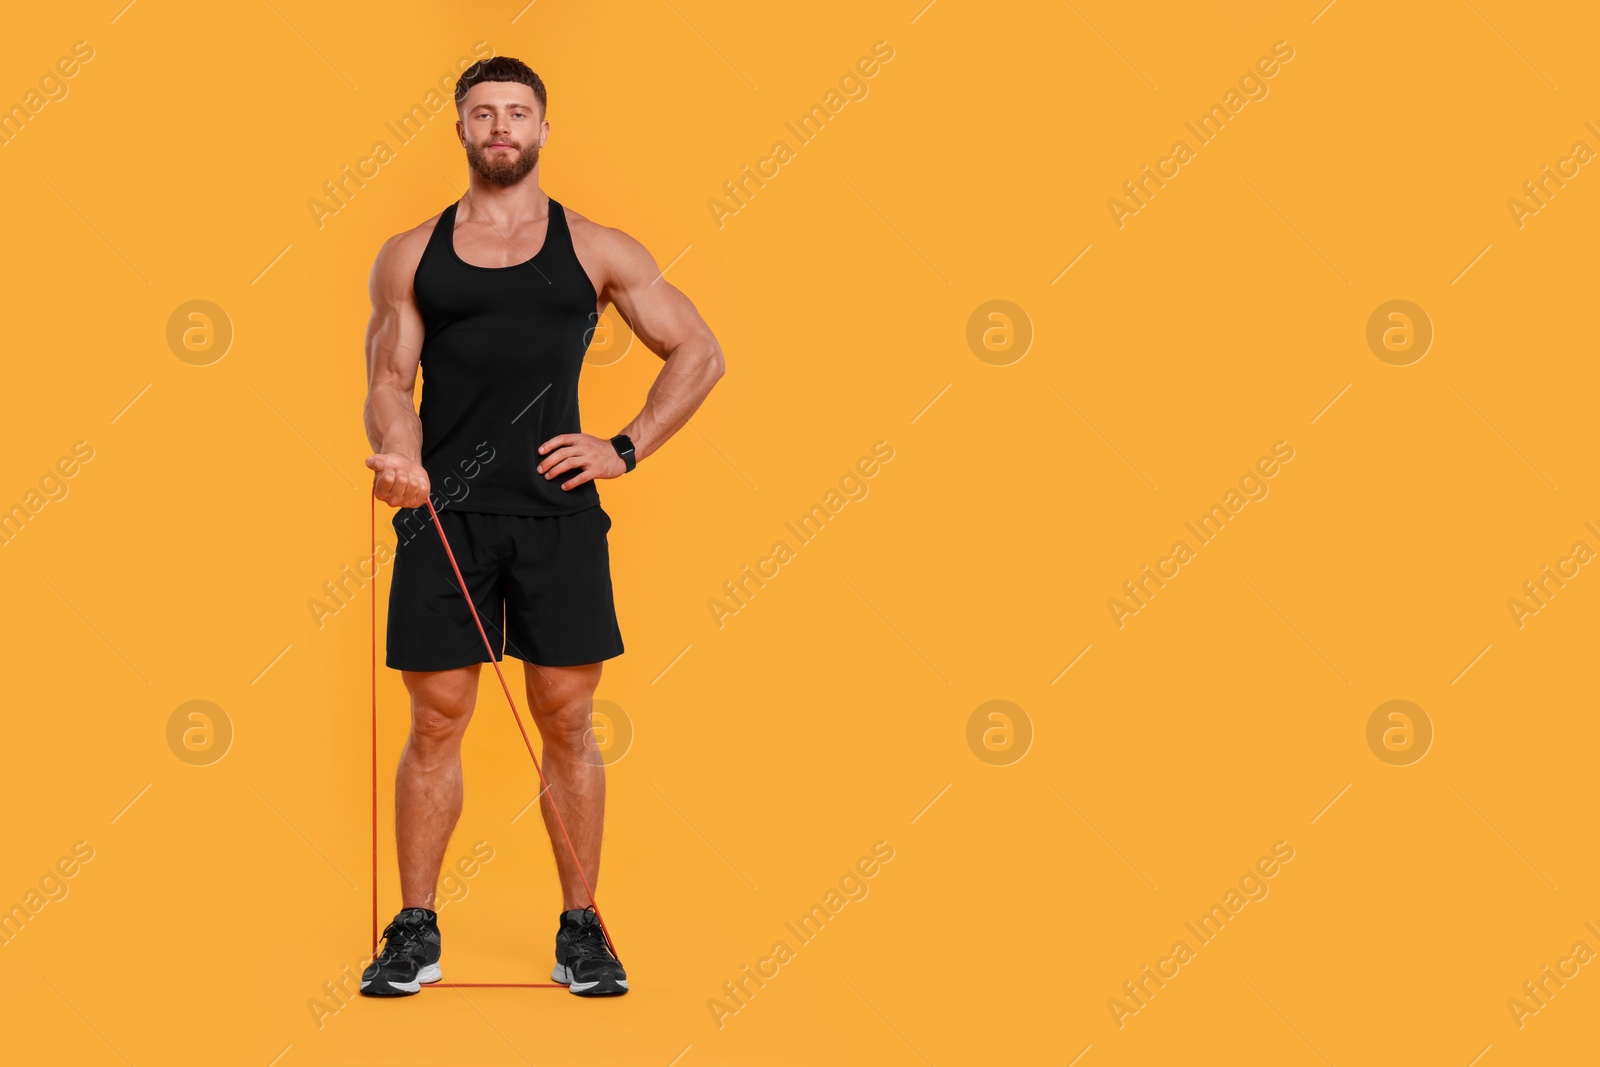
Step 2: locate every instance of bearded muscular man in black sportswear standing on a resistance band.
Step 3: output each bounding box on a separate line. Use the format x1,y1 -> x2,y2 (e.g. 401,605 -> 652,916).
362,56 -> 723,997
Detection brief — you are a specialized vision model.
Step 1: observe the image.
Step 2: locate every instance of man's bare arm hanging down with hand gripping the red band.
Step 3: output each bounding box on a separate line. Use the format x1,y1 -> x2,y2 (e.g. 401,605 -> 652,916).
363,227 -> 430,507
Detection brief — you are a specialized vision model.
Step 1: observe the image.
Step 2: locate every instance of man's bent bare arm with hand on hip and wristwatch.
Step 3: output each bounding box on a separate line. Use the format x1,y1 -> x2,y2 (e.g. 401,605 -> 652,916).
539,229 -> 725,490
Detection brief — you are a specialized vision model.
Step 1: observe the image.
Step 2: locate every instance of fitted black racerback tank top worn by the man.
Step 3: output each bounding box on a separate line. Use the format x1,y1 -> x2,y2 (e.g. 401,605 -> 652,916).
413,197 -> 600,515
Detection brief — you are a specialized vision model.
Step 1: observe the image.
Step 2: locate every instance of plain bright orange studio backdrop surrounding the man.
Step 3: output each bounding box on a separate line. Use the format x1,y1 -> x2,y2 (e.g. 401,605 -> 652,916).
0,0 -> 1600,1067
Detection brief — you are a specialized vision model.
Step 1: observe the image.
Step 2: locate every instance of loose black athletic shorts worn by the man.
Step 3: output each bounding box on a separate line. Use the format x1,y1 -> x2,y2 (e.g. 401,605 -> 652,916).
384,504 -> 622,670
